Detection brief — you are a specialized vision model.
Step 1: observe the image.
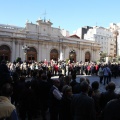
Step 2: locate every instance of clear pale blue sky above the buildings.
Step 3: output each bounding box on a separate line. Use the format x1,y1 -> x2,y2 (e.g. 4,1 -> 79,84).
0,0 -> 120,33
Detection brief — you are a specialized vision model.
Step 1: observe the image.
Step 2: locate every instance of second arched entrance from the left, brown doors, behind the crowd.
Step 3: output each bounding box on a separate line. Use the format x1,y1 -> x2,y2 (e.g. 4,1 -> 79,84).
27,47 -> 37,61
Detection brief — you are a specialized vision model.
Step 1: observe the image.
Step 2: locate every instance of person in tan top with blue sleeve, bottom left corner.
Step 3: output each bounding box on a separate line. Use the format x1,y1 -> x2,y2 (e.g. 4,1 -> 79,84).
0,83 -> 18,120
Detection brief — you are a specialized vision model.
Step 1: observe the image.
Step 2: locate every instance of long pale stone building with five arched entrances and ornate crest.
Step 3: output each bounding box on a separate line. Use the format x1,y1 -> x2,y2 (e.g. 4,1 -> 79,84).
0,19 -> 100,62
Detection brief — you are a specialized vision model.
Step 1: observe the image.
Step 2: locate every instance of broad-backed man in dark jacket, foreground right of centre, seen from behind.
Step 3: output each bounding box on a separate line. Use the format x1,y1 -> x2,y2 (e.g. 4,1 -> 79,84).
71,81 -> 96,120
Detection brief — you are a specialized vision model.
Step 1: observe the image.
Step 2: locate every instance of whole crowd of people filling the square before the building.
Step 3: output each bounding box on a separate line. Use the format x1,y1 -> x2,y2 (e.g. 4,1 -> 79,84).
0,60 -> 120,120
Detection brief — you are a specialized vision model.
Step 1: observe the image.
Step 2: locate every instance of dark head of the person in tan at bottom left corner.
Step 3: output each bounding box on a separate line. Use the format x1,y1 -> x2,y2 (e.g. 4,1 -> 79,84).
1,83 -> 13,97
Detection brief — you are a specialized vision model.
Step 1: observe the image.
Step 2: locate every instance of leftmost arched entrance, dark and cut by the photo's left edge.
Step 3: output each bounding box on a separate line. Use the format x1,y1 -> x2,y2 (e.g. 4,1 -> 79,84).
0,45 -> 11,62
